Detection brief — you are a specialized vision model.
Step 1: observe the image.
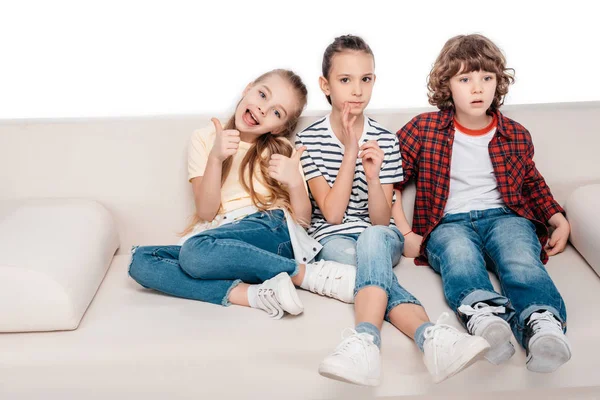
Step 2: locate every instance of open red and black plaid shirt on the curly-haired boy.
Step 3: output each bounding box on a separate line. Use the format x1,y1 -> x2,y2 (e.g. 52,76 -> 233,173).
394,110 -> 564,265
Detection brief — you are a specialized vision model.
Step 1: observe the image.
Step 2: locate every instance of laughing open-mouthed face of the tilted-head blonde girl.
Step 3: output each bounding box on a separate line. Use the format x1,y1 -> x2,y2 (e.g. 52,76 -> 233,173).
235,74 -> 299,136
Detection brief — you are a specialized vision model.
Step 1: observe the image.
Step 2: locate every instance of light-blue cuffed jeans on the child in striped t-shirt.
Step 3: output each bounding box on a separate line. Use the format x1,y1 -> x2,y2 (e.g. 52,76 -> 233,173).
316,225 -> 421,321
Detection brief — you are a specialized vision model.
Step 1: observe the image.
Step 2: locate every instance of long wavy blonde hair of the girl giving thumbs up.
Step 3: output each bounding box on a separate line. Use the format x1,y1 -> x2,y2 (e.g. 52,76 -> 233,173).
180,69 -> 308,236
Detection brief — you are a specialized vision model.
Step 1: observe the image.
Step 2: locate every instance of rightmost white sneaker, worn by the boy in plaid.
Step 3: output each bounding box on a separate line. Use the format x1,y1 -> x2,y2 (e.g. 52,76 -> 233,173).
525,311 -> 571,372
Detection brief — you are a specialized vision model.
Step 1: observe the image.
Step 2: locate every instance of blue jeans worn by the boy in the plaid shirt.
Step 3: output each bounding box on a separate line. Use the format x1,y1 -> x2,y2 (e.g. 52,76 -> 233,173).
426,207 -> 567,344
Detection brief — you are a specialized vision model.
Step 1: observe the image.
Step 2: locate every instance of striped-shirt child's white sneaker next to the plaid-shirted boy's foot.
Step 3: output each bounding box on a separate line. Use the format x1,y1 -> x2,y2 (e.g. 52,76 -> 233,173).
423,313 -> 490,383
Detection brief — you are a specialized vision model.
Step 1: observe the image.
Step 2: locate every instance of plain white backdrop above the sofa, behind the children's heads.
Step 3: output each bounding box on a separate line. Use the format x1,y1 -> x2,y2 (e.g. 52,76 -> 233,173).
0,0 -> 600,119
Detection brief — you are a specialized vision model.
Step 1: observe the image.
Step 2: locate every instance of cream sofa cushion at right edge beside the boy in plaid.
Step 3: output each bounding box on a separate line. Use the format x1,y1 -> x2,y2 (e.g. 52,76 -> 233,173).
565,184 -> 600,275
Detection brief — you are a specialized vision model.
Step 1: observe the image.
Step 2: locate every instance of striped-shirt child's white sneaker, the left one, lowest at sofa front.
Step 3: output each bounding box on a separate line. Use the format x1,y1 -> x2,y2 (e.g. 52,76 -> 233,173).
319,328 -> 381,386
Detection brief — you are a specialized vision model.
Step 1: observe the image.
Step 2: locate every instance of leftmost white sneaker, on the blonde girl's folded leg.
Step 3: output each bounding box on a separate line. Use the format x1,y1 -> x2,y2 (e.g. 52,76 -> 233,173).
256,272 -> 304,319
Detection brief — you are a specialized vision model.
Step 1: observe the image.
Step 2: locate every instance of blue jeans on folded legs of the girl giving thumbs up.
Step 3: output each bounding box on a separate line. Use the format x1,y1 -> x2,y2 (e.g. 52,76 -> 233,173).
129,210 -> 298,306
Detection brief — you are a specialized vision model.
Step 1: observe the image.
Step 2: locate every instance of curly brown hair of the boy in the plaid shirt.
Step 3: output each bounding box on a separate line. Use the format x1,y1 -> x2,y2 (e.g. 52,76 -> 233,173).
427,34 -> 515,111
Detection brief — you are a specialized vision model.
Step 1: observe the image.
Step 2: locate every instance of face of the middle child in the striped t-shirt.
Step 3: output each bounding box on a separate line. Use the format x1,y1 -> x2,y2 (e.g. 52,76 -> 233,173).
319,51 -> 375,115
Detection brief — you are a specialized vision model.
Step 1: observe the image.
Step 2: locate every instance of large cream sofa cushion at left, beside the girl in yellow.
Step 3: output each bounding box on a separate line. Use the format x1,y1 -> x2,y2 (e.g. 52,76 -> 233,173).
0,199 -> 119,332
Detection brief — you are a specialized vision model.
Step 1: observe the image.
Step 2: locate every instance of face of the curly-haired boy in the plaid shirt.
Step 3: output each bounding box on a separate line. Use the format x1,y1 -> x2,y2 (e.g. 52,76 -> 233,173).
450,71 -> 497,119
